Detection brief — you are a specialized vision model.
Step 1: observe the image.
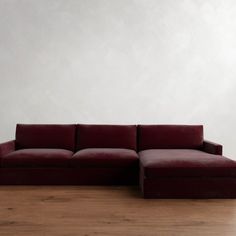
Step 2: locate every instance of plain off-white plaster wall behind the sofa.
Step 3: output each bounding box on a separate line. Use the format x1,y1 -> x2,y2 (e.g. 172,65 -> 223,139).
0,0 -> 236,159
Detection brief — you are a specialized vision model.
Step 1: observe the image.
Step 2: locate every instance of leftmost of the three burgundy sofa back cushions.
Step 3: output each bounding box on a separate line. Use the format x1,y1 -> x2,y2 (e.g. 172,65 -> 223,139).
16,124 -> 76,151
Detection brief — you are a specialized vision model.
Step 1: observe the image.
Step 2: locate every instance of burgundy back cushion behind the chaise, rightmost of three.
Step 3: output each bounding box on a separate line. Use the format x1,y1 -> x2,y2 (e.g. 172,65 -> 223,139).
138,125 -> 203,150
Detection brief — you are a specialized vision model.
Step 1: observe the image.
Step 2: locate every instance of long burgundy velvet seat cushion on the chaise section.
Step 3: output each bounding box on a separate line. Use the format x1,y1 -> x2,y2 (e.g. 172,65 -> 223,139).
139,149 -> 236,178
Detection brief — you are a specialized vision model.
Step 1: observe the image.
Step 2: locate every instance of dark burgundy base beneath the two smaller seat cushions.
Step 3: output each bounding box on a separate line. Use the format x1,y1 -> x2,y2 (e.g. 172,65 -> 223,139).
0,168 -> 138,185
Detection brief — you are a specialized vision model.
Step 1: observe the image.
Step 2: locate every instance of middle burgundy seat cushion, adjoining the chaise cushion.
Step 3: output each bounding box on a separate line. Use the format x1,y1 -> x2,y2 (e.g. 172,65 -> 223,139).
71,148 -> 138,168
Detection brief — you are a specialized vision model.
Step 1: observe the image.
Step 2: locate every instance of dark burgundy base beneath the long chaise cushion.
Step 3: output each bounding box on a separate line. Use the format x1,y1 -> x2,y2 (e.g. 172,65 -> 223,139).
140,177 -> 236,199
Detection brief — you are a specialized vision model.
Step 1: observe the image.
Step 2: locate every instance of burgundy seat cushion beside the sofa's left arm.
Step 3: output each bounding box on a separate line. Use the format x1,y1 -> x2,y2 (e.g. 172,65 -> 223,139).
1,148 -> 73,168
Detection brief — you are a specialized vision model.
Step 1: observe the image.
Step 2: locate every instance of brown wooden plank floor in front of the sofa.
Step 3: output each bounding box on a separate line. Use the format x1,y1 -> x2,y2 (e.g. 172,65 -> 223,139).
0,186 -> 236,236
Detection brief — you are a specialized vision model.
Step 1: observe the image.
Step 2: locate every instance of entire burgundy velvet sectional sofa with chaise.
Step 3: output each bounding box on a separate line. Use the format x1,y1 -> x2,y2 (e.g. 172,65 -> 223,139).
0,124 -> 236,198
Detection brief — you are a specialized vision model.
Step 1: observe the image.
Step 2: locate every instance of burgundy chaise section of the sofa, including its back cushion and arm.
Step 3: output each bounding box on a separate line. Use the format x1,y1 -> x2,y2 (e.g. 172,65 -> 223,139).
138,125 -> 236,198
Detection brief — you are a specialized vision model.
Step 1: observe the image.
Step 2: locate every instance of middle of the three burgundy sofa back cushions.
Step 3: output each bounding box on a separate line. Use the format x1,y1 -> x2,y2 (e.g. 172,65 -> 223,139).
76,124 -> 137,150
